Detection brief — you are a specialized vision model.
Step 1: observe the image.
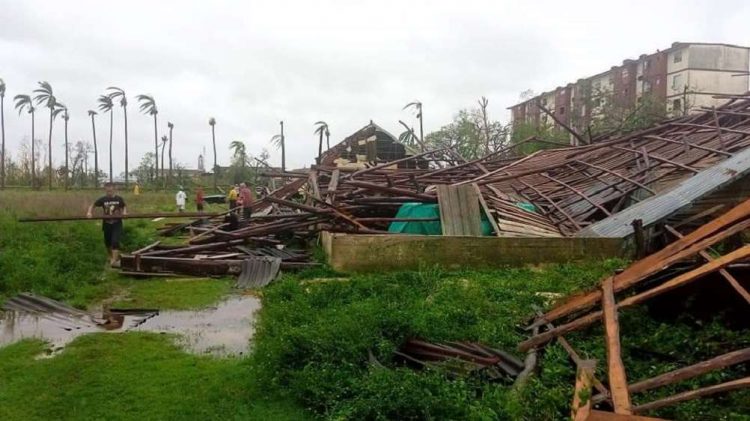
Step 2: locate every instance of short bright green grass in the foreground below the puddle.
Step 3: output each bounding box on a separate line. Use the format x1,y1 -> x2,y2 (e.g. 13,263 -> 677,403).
0,333 -> 306,421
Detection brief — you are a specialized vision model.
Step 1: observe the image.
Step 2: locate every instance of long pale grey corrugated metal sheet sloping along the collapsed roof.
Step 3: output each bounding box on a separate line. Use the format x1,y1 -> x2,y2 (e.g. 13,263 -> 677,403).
576,145 -> 750,238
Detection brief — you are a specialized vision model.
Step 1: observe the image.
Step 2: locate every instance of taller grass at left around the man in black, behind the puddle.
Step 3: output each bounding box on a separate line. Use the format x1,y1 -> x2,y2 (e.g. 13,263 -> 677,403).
0,191 -> 172,307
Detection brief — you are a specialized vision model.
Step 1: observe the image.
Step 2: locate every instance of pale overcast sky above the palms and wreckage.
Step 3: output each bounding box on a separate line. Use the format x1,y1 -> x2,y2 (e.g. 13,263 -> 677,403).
0,0 -> 750,173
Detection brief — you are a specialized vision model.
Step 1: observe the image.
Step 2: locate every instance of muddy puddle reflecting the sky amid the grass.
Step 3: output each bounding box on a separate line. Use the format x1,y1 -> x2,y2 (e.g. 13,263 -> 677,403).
0,296 -> 260,356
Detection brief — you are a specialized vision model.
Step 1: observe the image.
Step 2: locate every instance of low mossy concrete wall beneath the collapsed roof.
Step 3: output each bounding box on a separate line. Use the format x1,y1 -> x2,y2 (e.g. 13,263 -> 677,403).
323,233 -> 628,272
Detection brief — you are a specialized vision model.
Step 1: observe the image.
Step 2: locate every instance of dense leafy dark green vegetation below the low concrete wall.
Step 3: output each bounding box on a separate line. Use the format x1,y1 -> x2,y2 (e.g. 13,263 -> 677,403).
249,268 -> 750,420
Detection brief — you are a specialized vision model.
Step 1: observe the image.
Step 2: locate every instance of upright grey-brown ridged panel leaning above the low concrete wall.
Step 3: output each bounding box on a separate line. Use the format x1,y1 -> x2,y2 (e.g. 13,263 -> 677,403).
437,185 -> 482,236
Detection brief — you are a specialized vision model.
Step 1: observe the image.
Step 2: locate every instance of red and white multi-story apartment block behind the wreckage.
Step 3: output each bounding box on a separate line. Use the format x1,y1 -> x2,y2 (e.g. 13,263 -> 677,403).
509,42 -> 750,142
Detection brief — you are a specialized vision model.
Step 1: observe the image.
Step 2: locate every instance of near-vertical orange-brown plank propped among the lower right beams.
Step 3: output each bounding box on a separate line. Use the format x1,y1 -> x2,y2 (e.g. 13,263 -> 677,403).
602,277 -> 632,414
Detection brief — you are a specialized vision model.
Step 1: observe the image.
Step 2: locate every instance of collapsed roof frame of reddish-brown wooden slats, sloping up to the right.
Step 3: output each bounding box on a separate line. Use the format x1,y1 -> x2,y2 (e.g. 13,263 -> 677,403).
302,96 -> 750,236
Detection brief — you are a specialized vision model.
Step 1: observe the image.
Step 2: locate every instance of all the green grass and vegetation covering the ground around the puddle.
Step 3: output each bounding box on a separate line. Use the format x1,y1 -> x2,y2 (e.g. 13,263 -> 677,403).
0,192 -> 750,421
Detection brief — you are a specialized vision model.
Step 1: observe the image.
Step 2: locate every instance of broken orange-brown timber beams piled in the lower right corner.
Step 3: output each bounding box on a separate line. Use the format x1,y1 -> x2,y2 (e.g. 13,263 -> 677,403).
519,200 -> 750,420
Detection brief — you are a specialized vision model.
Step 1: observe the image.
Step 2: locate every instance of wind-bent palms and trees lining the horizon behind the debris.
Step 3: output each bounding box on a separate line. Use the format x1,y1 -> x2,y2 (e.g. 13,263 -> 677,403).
0,79 -> 539,189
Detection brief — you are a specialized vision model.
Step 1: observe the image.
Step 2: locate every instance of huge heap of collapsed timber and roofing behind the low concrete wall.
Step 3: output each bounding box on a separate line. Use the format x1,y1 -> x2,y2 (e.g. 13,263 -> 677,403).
111,97 -> 750,275
